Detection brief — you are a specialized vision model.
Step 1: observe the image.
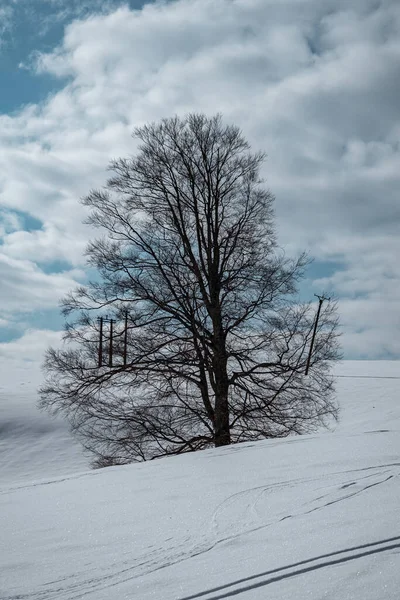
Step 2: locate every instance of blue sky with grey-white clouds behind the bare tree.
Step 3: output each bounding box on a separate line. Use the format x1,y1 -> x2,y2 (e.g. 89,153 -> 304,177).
0,0 -> 400,385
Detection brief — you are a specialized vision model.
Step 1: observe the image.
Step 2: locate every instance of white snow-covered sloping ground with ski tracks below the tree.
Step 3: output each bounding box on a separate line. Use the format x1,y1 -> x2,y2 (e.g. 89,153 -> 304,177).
0,362 -> 400,600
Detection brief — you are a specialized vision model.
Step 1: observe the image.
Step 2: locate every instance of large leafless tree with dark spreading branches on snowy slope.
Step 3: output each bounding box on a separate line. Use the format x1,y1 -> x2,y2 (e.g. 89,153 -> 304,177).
40,114 -> 338,466
